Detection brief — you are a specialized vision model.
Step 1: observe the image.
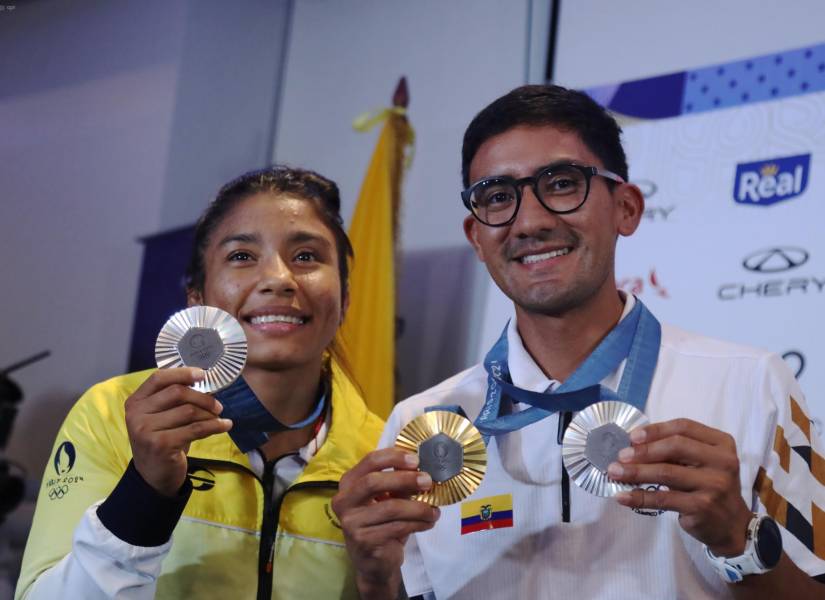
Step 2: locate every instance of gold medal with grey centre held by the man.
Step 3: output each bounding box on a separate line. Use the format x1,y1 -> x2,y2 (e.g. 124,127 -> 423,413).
395,410 -> 487,506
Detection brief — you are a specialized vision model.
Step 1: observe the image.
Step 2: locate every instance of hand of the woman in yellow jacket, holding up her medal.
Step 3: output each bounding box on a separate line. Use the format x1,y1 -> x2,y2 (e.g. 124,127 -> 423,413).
125,367 -> 232,496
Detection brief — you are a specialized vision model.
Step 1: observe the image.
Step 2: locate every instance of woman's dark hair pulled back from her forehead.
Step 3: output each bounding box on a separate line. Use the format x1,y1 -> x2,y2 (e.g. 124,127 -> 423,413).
186,165 -> 353,301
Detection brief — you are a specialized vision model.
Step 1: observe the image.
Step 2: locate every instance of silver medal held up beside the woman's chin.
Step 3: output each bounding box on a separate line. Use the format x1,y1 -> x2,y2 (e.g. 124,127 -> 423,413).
155,306 -> 246,394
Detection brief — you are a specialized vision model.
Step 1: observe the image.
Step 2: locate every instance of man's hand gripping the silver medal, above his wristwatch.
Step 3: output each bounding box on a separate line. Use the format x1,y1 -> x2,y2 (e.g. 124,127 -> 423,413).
608,419 -> 752,556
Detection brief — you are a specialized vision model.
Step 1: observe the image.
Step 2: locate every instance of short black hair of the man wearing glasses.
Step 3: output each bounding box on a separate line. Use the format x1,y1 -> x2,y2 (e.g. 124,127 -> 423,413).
461,85 -> 627,188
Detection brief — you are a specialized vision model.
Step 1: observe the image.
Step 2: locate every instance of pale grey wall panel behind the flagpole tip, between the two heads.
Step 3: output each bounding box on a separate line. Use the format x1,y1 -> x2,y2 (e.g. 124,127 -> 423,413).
275,0 -> 532,250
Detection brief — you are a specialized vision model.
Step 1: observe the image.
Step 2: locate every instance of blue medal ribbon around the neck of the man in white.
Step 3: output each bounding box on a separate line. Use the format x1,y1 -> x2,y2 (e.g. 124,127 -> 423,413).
448,299 -> 662,442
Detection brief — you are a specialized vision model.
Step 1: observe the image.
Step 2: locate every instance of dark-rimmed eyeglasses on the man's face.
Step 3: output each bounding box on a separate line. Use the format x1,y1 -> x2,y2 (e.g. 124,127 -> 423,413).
461,164 -> 624,227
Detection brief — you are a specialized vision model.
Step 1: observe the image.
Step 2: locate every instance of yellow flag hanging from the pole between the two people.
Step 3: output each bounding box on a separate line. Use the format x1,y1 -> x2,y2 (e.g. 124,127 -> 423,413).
339,107 -> 413,419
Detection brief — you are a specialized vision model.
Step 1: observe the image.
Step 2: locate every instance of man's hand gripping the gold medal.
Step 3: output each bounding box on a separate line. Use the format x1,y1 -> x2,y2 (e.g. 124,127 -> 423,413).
332,448 -> 440,600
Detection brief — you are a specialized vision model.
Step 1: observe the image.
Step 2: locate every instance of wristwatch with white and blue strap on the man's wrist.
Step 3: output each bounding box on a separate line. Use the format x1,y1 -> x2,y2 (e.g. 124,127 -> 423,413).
705,514 -> 782,583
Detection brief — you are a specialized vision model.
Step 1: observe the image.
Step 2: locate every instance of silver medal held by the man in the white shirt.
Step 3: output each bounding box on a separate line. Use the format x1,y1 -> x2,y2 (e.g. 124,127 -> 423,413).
561,400 -> 647,497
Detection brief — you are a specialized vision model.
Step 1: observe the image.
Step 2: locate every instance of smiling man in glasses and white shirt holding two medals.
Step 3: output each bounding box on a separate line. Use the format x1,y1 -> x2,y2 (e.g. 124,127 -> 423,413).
333,86 -> 825,599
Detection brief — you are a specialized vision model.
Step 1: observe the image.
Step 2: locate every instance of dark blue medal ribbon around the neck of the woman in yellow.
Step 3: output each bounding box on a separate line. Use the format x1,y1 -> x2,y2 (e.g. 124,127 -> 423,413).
215,377 -> 327,453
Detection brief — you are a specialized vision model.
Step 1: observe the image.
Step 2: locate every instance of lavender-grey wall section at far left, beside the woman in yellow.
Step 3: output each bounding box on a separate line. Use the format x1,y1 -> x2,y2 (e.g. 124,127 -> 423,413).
0,1 -> 185,479
